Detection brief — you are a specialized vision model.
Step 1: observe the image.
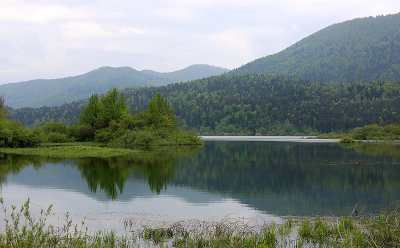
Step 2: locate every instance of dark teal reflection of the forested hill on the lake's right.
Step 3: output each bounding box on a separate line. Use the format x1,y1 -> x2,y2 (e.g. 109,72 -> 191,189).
172,142 -> 400,215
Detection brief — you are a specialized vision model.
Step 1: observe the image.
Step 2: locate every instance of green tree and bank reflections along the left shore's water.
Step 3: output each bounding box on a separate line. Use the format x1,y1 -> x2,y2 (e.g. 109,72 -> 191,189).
0,146 -> 201,199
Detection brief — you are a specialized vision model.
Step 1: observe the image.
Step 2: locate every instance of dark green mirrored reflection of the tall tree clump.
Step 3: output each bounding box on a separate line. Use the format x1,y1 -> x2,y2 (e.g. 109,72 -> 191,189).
75,146 -> 200,199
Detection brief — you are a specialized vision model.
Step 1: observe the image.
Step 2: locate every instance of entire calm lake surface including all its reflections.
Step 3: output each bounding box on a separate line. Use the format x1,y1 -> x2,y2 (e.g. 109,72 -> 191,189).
0,140 -> 400,232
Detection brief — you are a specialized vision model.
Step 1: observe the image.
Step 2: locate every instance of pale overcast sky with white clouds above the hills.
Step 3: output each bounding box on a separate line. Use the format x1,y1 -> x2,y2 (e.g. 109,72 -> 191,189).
0,0 -> 400,84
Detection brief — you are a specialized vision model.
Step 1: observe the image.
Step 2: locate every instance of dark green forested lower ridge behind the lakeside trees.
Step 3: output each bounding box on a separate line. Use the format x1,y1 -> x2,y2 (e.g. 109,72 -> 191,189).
11,74 -> 400,135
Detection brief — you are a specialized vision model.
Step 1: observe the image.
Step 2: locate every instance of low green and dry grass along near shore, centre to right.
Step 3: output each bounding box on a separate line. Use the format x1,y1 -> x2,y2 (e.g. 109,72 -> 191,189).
133,210 -> 400,248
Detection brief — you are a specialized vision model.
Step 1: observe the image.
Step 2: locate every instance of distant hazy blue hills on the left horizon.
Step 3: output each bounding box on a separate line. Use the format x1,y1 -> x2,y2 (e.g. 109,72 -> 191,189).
0,65 -> 228,108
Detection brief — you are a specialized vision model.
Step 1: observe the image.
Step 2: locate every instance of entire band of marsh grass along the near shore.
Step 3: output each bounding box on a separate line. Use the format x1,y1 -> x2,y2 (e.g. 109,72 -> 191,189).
0,198 -> 400,248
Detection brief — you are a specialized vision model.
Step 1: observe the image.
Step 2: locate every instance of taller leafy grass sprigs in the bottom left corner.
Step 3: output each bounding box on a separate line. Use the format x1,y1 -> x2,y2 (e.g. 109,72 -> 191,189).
0,198 -> 134,248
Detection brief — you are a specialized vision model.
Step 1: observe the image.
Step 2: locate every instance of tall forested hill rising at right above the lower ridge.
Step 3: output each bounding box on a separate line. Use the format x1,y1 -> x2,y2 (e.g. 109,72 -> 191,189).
232,14 -> 400,83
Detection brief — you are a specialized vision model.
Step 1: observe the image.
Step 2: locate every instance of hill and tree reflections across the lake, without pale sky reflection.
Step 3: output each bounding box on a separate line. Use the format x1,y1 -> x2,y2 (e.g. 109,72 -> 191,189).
0,141 -> 400,216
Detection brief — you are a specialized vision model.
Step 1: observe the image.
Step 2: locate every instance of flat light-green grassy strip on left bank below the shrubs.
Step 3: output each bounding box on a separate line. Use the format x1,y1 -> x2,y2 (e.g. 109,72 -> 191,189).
0,144 -> 138,158
